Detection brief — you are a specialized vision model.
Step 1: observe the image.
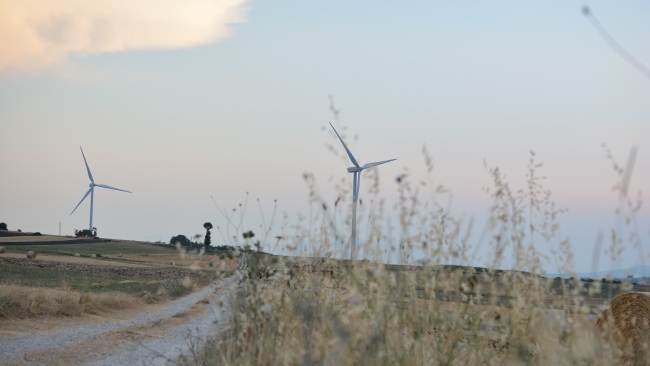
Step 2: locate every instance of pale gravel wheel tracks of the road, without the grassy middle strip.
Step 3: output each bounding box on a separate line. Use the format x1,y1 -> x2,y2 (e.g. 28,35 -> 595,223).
0,274 -> 240,365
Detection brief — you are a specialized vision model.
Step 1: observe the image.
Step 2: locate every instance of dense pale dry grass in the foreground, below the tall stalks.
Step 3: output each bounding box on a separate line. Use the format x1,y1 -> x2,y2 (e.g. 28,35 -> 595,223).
204,264 -> 597,365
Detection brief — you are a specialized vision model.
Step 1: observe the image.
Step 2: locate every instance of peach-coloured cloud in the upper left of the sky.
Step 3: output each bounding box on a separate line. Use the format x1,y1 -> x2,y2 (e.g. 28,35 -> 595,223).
0,0 -> 246,69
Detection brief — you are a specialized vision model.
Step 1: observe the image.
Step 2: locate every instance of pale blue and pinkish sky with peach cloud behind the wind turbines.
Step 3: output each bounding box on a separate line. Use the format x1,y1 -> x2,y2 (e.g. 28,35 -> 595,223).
0,0 -> 650,272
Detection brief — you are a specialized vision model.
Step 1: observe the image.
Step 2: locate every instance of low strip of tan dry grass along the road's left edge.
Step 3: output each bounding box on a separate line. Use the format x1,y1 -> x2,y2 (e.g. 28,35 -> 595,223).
0,285 -> 141,318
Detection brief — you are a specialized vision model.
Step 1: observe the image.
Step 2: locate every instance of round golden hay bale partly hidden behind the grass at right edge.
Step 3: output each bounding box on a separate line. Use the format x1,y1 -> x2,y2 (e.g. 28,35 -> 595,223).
594,291 -> 650,365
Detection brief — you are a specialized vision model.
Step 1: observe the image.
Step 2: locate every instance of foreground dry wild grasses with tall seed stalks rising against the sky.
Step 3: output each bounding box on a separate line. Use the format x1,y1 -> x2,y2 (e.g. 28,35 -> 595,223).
191,144 -> 650,365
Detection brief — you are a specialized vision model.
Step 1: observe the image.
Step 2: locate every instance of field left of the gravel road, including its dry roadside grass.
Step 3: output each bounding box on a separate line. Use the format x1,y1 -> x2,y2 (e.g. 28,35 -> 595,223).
0,242 -> 235,321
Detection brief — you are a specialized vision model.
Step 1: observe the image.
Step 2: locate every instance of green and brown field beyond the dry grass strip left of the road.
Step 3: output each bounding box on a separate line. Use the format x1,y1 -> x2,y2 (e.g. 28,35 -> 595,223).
0,236 -> 238,319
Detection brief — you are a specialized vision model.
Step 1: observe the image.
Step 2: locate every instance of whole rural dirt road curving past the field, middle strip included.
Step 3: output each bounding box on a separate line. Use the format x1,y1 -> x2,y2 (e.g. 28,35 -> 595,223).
0,274 -> 240,365
